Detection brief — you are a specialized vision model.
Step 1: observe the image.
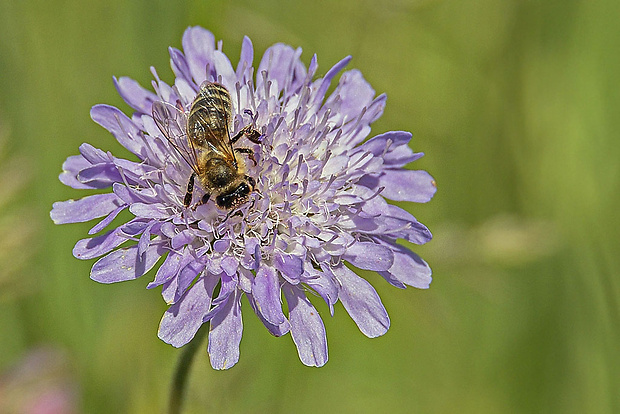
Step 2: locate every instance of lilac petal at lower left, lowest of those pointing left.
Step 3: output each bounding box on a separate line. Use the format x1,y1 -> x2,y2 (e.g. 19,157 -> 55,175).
90,245 -> 162,283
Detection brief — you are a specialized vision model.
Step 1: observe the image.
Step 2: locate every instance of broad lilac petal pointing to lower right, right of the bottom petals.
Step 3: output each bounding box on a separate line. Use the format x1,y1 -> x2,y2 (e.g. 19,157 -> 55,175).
332,266 -> 390,338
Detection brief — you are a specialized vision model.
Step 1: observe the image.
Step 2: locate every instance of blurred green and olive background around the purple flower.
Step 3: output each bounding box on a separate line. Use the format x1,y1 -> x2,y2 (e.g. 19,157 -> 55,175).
0,0 -> 620,413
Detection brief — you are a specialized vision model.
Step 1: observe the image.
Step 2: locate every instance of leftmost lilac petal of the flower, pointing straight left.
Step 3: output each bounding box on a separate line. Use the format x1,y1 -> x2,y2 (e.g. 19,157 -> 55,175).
50,193 -> 123,224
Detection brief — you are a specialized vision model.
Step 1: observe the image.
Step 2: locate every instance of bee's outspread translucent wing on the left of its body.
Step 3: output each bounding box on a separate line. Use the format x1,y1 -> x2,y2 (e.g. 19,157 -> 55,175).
152,101 -> 199,174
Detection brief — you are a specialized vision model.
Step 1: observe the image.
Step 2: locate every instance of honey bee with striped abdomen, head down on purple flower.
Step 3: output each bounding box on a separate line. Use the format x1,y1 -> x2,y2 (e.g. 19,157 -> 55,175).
153,82 -> 260,210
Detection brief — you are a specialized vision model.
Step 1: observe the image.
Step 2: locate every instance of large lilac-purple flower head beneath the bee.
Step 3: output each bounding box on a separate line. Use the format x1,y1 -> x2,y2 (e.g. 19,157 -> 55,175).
51,27 -> 436,369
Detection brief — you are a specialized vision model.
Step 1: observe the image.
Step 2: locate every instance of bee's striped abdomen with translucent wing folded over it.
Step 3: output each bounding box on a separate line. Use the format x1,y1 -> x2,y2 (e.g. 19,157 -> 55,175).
189,82 -> 237,165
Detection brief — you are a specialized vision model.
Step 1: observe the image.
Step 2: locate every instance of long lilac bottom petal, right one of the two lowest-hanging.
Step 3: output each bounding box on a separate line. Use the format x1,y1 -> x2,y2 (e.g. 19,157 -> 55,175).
283,284 -> 327,367
